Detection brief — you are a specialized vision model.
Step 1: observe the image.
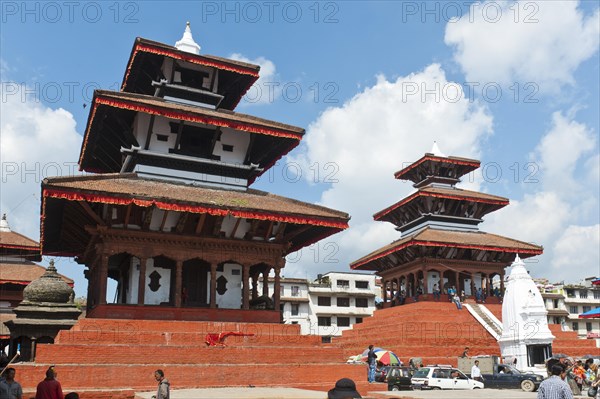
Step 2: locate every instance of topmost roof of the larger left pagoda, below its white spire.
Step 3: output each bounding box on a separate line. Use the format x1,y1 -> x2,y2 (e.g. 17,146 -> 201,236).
121,37 -> 260,110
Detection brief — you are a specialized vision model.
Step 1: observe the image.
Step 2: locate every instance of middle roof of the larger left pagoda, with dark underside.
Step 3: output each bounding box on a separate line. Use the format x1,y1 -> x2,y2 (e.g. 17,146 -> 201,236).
79,90 -> 304,180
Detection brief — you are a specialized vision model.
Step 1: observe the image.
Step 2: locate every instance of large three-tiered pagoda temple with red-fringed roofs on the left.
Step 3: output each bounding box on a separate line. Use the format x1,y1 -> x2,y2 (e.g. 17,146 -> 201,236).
41,24 -> 349,322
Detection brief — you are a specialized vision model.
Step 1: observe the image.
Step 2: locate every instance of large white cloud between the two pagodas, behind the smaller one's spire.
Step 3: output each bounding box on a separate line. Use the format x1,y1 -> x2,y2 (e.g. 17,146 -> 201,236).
286,64 -> 492,276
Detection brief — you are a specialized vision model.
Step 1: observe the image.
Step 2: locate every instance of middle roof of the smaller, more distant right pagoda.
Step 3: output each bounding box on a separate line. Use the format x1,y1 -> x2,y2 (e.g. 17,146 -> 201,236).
373,186 -> 509,227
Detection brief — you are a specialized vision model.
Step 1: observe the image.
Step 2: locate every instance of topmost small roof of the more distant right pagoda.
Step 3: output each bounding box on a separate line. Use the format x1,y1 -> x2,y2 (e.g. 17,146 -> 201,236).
394,153 -> 481,187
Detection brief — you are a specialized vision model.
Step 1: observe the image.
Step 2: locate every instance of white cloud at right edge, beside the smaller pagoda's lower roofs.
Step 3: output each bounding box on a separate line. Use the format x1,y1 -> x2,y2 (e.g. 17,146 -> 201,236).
485,112 -> 600,282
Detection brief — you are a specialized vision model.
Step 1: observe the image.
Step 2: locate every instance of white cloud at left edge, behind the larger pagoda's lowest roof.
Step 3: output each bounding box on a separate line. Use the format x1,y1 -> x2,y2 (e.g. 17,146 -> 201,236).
0,82 -> 87,295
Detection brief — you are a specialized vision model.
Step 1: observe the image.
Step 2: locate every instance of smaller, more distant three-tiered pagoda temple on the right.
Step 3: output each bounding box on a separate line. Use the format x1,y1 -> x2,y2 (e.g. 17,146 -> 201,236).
350,144 -> 543,302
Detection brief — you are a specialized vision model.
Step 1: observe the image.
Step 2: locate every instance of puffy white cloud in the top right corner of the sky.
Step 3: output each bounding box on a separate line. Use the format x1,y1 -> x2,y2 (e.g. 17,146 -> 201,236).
445,0 -> 600,91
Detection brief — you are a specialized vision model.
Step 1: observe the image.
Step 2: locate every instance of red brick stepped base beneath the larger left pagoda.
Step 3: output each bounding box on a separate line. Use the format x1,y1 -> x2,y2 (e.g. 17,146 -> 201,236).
16,319 -> 369,399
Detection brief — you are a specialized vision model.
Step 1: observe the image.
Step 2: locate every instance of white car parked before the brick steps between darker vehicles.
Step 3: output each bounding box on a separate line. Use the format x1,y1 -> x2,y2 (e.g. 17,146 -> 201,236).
411,366 -> 483,389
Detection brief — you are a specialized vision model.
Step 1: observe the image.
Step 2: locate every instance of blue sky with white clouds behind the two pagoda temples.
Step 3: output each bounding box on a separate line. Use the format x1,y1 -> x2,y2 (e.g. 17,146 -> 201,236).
0,1 -> 600,295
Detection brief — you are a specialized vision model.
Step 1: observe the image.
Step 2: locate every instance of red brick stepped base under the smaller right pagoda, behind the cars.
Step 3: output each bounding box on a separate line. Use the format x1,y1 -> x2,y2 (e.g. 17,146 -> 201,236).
335,301 -> 600,365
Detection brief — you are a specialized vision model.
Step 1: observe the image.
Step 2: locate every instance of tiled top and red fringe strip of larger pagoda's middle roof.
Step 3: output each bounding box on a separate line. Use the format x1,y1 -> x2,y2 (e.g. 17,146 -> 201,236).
96,90 -> 306,135
